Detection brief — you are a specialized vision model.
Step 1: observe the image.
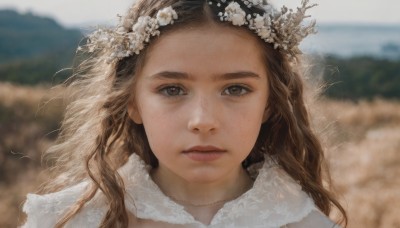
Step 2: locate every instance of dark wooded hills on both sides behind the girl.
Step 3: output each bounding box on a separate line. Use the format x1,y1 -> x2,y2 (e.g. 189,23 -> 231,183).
0,10 -> 400,100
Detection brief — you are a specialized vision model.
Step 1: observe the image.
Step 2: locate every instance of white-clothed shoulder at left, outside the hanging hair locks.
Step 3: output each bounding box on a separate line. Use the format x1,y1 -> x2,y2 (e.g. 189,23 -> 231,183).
22,182 -> 101,228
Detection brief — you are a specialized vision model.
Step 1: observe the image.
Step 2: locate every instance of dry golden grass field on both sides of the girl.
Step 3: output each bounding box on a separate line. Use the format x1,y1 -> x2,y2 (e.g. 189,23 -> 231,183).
0,84 -> 400,228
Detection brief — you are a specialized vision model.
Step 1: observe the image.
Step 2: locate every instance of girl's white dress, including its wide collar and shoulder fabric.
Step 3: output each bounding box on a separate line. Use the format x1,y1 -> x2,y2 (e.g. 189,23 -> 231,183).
23,154 -> 339,228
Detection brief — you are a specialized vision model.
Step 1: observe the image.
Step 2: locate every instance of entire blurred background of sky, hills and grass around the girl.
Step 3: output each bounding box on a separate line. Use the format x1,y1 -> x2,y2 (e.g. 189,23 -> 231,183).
0,0 -> 400,228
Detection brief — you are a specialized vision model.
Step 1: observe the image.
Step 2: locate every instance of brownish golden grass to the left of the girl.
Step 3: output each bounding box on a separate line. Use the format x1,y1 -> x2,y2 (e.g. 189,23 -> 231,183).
0,83 -> 63,227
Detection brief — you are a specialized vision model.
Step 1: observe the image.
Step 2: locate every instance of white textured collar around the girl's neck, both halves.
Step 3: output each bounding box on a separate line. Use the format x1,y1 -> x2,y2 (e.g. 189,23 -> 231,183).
120,154 -> 315,227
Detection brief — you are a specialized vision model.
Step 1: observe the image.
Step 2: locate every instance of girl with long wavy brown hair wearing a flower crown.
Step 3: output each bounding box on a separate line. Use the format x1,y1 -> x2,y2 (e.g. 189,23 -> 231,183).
23,0 -> 345,227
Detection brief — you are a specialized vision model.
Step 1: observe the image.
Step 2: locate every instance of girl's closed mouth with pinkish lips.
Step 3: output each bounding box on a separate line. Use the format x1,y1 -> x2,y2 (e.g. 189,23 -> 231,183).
183,146 -> 226,162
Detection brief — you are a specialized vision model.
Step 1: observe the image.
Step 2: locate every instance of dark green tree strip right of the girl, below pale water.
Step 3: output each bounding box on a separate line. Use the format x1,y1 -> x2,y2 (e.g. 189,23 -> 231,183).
324,56 -> 400,100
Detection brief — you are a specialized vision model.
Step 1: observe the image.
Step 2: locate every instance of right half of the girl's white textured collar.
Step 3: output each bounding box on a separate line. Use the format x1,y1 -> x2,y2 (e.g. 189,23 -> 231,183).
211,166 -> 315,227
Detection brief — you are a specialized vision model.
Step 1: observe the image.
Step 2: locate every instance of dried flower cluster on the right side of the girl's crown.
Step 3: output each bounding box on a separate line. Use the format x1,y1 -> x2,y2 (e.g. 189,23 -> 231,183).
214,0 -> 316,59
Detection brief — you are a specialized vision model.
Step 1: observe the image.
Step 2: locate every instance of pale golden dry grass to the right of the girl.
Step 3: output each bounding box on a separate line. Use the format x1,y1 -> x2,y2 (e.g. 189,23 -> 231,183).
317,100 -> 400,228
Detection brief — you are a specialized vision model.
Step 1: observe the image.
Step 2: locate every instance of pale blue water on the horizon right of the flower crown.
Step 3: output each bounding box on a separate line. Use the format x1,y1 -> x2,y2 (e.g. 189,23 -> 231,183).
301,25 -> 400,59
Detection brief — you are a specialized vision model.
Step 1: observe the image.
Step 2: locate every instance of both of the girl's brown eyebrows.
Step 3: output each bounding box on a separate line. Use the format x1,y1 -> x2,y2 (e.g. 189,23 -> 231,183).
150,71 -> 261,81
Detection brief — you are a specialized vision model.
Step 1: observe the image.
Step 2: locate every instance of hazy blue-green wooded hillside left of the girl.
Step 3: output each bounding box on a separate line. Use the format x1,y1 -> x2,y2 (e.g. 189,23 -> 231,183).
0,10 -> 83,84
